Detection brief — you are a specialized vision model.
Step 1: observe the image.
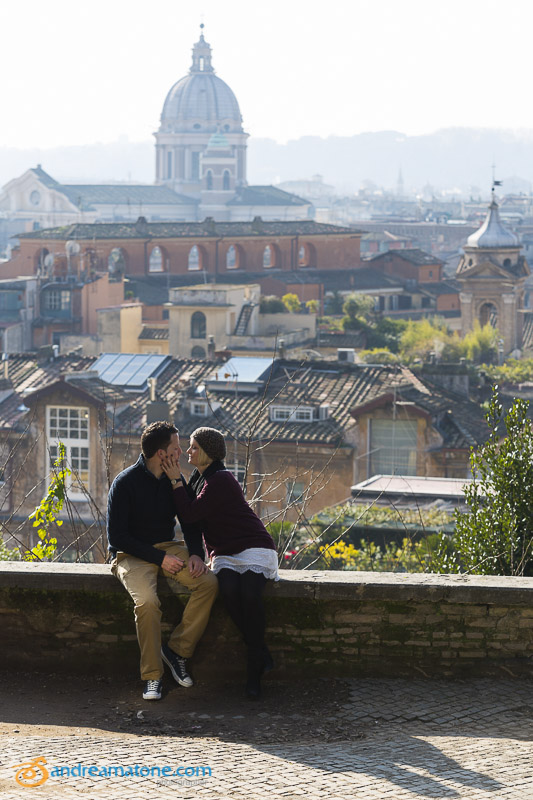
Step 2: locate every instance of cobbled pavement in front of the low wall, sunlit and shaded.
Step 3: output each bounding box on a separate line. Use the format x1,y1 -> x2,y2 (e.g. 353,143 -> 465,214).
0,675 -> 533,800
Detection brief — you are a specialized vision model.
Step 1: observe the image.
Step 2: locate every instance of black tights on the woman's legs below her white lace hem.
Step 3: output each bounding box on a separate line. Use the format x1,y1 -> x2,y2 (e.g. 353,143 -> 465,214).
217,569 -> 267,661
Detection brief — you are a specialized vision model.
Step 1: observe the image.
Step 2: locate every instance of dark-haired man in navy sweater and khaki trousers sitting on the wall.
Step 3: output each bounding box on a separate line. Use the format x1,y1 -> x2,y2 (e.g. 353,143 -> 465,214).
107,422 -> 217,700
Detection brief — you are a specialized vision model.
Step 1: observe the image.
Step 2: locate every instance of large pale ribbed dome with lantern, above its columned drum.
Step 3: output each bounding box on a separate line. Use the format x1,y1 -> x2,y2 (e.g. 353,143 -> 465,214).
160,33 -> 242,133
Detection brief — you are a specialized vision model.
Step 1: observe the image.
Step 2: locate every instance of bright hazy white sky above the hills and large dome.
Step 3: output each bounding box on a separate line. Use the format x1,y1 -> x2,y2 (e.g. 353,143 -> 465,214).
0,0 -> 533,148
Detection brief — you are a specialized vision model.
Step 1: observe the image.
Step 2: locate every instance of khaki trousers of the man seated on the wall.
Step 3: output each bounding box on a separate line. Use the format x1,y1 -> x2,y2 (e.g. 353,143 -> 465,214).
111,542 -> 218,681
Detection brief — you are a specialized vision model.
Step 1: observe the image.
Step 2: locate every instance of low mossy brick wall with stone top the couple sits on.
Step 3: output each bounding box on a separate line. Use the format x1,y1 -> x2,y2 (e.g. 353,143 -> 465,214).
0,562 -> 533,679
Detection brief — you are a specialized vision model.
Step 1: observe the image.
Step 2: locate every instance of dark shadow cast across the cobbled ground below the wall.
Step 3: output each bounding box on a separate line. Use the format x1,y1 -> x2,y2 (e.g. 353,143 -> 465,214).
5,673 -> 533,798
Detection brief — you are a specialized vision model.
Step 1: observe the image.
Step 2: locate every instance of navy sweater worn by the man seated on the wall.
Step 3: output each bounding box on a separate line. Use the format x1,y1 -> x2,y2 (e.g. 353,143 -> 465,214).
107,454 -> 204,566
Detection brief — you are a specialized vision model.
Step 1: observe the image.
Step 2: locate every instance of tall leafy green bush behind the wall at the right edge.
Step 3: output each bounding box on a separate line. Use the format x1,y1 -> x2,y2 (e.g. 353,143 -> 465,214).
432,387 -> 533,575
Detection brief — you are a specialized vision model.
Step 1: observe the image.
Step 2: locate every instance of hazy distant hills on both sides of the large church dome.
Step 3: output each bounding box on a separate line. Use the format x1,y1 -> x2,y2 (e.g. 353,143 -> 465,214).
0,128 -> 533,195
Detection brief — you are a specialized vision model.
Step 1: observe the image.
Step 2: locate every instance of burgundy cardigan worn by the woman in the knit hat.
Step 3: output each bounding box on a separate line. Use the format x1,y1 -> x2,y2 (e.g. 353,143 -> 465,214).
174,461 -> 276,557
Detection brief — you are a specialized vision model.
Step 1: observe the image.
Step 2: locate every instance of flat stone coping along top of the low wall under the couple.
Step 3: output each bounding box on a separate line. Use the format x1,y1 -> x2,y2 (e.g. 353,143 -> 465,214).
0,561 -> 533,606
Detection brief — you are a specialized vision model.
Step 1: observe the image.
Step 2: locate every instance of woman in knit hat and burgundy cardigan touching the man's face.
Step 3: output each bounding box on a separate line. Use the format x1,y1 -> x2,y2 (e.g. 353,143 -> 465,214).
163,427 -> 279,699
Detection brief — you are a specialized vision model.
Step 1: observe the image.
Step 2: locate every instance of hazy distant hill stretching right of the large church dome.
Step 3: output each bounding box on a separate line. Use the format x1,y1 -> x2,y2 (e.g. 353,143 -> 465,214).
248,128 -> 533,195
